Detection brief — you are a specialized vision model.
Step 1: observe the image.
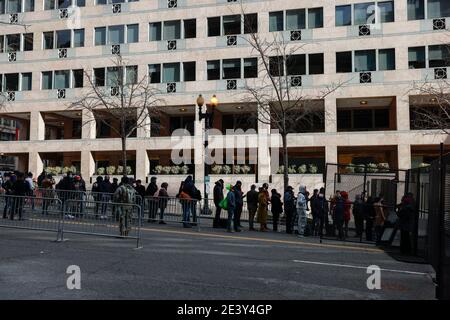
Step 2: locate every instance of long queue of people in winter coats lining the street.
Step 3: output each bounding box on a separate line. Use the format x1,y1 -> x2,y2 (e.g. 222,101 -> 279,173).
0,172 -> 414,252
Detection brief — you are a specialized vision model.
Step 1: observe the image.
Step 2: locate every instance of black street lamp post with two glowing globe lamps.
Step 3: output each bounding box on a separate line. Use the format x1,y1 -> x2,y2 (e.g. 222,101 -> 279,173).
197,94 -> 219,214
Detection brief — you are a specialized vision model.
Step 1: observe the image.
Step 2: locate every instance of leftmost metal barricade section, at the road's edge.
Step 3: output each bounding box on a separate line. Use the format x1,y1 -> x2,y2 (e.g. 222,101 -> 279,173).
0,194 -> 62,232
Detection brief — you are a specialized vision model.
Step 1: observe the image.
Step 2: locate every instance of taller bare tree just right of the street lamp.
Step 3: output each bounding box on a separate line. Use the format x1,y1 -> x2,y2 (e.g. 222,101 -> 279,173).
237,2 -> 344,189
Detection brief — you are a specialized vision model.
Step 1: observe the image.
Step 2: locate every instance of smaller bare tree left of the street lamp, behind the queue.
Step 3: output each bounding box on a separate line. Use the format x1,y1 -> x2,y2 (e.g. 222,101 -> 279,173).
68,55 -> 164,176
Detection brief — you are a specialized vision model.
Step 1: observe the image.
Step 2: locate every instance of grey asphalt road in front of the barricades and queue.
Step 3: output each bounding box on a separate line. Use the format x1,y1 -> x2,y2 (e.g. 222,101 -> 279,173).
0,225 -> 434,300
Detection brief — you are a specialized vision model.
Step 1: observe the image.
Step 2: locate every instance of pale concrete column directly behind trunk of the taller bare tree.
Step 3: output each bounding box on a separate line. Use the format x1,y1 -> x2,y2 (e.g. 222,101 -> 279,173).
257,106 -> 270,184
